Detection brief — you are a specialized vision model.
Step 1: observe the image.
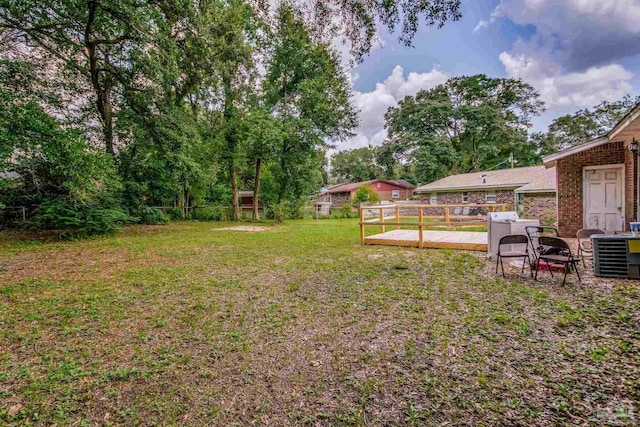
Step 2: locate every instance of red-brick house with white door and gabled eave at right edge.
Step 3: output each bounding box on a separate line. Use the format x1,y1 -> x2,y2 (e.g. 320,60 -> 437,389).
543,104 -> 640,237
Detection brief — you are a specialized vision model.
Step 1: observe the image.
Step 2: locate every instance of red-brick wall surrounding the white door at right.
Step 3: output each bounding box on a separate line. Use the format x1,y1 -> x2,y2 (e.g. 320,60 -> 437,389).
556,142 -> 635,237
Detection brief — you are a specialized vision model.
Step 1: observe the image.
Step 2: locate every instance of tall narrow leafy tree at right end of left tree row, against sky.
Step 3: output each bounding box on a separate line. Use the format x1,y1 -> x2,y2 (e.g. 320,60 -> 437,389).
263,6 -> 356,208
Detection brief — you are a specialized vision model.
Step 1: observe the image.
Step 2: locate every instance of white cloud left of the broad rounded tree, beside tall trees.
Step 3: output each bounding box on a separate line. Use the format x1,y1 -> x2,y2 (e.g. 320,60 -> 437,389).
338,65 -> 449,150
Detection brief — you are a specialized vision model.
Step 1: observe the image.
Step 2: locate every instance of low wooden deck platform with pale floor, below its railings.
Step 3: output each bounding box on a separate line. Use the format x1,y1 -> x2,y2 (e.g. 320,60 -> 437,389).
364,230 -> 488,251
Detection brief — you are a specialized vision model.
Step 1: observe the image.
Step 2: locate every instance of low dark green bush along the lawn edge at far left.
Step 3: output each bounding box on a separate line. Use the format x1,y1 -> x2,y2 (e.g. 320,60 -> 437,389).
25,199 -> 139,238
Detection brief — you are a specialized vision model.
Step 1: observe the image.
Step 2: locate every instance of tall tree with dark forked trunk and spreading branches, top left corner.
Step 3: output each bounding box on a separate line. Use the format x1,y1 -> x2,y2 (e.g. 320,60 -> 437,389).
0,0 -> 161,156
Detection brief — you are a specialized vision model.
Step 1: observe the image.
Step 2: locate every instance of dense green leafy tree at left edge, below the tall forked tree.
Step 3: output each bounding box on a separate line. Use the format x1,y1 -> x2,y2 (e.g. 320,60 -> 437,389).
0,80 -> 126,235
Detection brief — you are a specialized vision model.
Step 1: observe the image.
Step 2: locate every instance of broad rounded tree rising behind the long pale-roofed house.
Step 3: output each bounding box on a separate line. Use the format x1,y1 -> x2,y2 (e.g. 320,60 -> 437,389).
385,74 -> 543,182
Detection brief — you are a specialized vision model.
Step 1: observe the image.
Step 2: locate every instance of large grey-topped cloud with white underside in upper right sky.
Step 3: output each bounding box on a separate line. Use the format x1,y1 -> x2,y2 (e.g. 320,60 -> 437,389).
478,0 -> 640,109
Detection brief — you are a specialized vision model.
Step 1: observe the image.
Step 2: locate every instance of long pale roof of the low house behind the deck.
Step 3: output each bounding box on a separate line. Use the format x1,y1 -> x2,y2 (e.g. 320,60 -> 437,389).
416,166 -> 556,193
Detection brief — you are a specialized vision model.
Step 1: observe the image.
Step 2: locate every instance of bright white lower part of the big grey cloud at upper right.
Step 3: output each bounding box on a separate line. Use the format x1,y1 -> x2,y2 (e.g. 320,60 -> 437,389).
500,52 -> 633,108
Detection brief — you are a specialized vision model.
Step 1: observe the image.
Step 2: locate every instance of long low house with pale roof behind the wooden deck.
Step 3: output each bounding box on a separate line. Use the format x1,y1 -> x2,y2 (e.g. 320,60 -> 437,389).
416,166 -> 556,224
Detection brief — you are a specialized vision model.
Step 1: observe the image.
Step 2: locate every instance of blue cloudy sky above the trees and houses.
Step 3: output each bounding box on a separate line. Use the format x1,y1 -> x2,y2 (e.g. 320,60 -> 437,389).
337,0 -> 640,150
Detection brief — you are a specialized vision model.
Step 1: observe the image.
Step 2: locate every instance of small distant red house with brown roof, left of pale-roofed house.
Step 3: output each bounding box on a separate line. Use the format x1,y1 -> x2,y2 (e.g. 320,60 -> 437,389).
318,179 -> 416,208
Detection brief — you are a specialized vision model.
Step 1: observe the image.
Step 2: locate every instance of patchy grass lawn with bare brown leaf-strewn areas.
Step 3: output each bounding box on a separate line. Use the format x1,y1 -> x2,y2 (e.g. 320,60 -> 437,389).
0,220 -> 640,426
